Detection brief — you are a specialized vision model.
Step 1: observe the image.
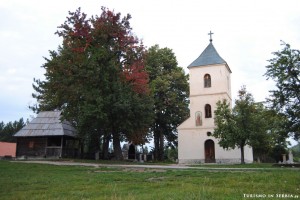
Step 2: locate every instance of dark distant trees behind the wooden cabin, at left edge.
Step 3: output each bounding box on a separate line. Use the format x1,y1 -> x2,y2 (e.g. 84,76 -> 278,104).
0,118 -> 28,142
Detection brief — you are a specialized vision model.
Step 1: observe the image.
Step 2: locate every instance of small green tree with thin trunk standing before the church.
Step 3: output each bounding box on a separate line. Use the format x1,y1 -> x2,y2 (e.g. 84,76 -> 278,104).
213,86 -> 266,164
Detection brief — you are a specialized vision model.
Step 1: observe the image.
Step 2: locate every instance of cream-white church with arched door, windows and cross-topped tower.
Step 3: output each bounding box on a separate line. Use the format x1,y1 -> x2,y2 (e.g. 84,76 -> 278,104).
178,32 -> 253,163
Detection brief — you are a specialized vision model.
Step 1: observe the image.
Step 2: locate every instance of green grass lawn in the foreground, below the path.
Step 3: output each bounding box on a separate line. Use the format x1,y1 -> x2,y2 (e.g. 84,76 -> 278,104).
0,161 -> 300,200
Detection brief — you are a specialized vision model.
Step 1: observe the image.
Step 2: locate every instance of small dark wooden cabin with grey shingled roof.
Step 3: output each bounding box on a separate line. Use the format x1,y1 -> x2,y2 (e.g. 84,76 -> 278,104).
14,111 -> 79,158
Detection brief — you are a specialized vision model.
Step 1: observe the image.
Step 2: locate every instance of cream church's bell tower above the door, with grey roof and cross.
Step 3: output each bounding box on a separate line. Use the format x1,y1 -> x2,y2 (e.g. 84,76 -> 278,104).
188,32 -> 231,132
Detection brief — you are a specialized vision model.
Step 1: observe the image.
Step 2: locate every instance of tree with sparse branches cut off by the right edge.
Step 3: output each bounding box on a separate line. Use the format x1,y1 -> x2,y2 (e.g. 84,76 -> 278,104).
265,42 -> 300,140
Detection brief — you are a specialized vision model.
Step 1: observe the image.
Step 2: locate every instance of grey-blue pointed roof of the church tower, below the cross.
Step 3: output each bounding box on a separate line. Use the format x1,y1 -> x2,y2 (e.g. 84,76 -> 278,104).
188,40 -> 226,68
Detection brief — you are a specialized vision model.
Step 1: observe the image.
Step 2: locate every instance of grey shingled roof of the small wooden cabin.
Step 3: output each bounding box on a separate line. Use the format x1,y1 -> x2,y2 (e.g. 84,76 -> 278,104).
14,111 -> 76,137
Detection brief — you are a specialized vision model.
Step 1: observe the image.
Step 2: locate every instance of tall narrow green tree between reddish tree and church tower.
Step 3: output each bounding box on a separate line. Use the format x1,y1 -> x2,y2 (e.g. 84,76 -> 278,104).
146,45 -> 189,160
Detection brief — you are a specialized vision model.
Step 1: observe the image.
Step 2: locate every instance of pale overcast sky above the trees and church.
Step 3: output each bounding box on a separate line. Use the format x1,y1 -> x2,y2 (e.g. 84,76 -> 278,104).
0,0 -> 300,133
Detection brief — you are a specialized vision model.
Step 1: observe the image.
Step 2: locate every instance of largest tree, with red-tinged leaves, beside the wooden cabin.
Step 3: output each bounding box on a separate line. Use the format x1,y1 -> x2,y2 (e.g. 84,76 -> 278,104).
31,7 -> 152,159
